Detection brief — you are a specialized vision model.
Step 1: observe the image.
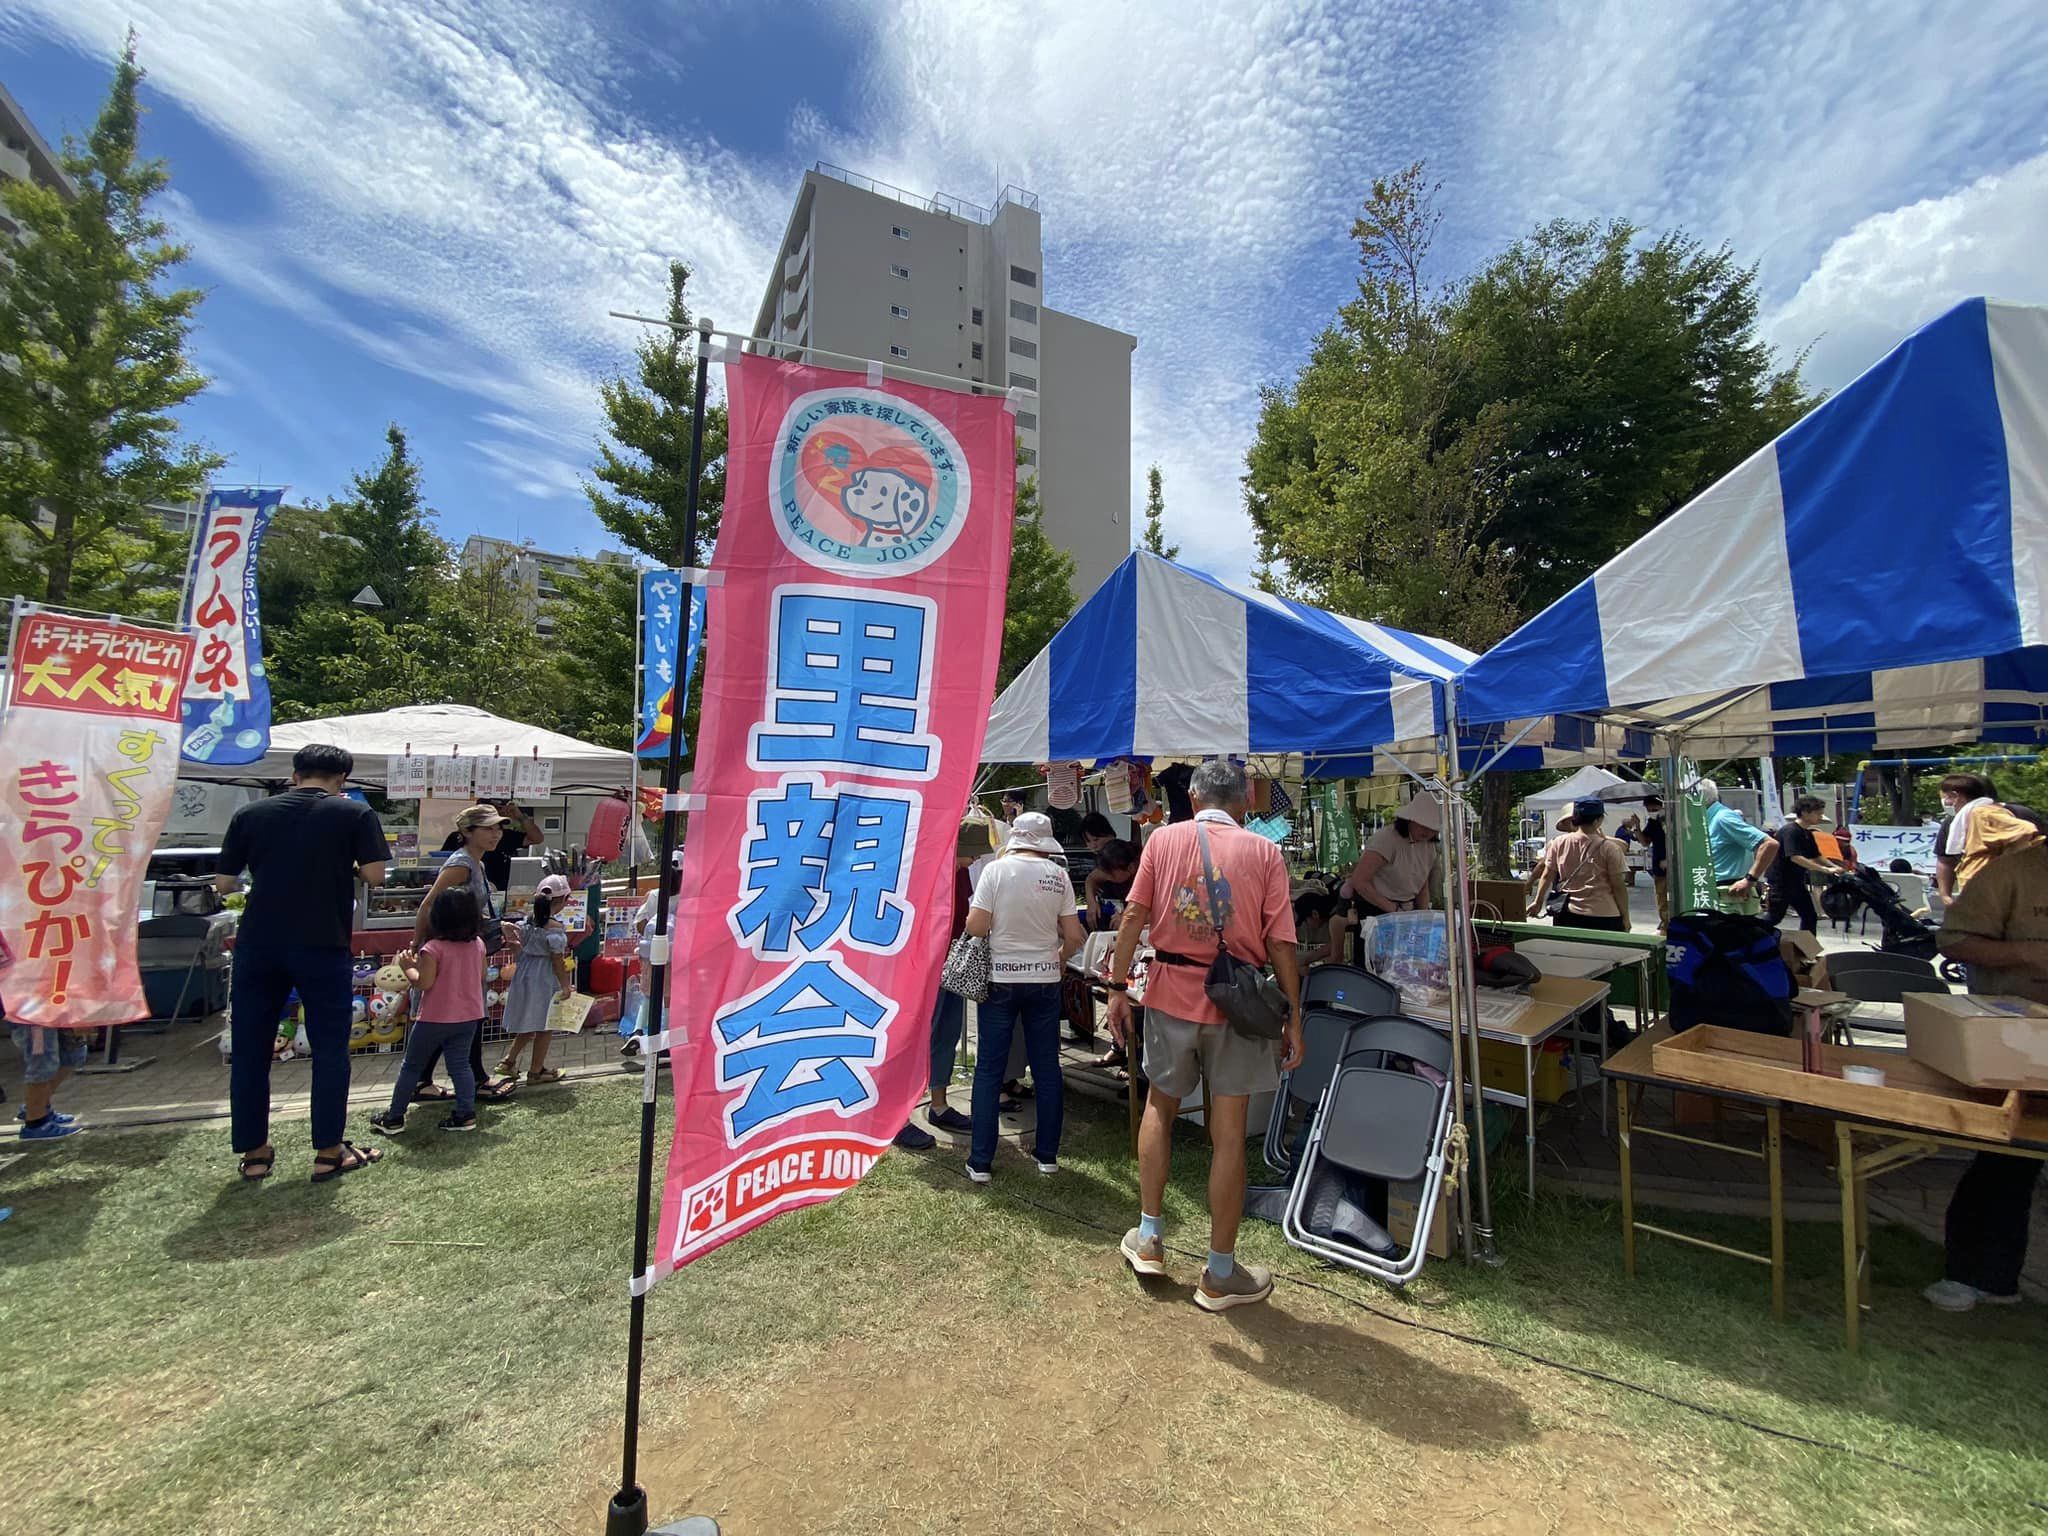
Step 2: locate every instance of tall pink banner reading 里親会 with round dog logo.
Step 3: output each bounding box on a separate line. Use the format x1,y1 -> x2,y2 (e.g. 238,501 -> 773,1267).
655,354 -> 1016,1276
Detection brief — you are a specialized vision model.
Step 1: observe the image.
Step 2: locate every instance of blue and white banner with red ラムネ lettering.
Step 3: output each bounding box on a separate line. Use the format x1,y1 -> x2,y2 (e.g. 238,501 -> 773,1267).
184,487 -> 285,762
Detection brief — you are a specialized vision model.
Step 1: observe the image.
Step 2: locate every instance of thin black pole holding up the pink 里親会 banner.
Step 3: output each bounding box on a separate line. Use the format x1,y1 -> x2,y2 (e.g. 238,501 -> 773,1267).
604,317 -> 717,1536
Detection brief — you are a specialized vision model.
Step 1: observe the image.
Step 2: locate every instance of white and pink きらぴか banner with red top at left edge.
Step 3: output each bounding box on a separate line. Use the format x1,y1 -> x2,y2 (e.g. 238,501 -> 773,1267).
0,612 -> 193,1030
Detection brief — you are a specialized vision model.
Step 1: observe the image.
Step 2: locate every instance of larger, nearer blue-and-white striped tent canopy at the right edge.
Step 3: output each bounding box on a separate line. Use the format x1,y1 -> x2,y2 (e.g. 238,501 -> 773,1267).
1456,299 -> 2048,758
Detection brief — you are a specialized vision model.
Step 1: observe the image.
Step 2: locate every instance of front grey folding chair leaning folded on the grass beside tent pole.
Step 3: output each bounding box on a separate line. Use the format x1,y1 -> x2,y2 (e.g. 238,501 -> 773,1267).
1280,1018 -> 1452,1286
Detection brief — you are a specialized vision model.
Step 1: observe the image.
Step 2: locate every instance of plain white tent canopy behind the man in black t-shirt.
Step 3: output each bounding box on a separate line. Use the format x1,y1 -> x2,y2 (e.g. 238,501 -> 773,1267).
180,705 -> 635,795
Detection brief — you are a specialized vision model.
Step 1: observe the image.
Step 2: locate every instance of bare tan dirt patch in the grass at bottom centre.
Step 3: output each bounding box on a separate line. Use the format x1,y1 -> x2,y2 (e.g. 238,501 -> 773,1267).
577,1260 -> 1735,1536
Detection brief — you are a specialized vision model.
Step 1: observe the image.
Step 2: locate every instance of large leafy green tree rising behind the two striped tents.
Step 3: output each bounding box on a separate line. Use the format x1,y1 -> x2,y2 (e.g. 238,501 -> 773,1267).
1245,164 -> 1812,870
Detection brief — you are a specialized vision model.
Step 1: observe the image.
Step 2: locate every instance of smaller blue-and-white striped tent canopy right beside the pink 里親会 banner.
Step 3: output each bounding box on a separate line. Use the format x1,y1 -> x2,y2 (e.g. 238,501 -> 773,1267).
981,551 -> 1473,772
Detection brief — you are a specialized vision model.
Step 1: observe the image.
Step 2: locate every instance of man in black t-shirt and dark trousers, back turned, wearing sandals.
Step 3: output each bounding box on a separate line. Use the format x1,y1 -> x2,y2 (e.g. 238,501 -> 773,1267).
213,745 -> 391,1184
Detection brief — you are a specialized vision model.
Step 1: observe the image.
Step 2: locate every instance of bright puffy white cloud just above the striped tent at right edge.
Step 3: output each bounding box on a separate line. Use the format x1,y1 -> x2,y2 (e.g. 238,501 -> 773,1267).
1765,154 -> 2048,389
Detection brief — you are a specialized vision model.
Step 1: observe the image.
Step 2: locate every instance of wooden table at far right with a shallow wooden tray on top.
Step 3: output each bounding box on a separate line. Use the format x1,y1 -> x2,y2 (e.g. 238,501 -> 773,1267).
1606,1026 -> 2048,1352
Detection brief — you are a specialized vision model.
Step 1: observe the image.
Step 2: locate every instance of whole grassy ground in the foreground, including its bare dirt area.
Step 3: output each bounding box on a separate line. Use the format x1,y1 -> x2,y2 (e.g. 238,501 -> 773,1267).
0,1077 -> 2048,1536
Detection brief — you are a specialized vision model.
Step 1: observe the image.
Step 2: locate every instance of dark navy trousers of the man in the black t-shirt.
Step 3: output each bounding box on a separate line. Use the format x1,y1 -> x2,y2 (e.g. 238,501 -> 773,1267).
227,944 -> 352,1153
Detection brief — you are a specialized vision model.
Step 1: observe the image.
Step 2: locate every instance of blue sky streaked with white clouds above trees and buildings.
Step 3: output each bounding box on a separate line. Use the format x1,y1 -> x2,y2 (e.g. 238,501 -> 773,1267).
0,0 -> 2048,573
